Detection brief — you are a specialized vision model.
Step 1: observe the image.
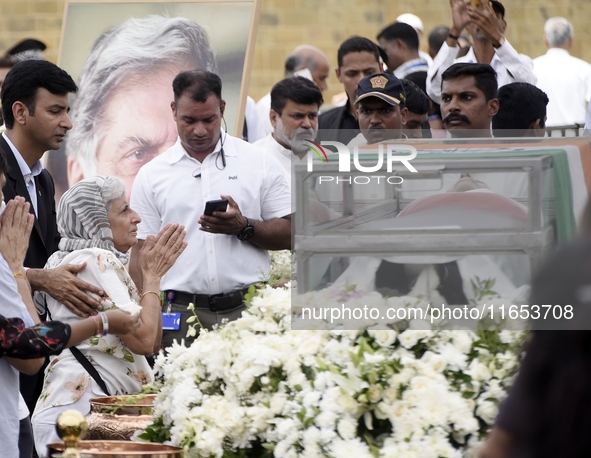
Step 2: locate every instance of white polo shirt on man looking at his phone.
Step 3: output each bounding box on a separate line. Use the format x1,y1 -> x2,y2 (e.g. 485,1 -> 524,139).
131,132 -> 291,294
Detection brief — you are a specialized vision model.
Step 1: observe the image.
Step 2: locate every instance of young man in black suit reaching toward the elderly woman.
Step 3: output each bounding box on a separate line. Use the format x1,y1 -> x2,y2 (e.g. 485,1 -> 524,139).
0,60 -> 104,457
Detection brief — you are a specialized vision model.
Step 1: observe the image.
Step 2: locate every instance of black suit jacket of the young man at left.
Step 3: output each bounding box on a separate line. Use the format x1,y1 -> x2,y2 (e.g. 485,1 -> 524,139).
0,135 -> 60,268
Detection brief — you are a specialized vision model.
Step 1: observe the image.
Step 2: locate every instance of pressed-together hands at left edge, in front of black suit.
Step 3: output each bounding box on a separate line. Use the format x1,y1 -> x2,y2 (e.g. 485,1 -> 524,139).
0,196 -> 35,272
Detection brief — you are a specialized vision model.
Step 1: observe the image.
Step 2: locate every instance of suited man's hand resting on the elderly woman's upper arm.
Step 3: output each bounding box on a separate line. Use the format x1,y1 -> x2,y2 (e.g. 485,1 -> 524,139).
39,263 -> 106,317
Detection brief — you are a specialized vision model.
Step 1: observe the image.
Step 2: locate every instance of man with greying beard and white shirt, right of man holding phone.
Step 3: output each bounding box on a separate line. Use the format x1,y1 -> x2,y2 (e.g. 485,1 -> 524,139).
254,76 -> 324,182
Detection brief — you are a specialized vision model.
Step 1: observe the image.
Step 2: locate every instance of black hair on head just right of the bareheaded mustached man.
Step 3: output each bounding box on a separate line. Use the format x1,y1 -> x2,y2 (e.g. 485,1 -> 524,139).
492,83 -> 549,137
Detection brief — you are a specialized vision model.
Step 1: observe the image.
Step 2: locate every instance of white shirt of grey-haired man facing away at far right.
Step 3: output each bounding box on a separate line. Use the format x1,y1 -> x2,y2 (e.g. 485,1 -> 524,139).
534,48 -> 591,127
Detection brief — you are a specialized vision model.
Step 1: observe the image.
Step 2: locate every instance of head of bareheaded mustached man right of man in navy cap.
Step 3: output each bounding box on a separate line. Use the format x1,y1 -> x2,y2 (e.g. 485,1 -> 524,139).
441,63 -> 499,138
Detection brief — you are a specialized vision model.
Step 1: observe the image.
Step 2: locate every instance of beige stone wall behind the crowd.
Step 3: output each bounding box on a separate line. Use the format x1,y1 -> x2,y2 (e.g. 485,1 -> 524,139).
0,0 -> 591,104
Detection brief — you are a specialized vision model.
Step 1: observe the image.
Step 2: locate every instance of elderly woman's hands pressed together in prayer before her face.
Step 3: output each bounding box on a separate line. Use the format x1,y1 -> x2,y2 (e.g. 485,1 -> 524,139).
139,223 -> 187,280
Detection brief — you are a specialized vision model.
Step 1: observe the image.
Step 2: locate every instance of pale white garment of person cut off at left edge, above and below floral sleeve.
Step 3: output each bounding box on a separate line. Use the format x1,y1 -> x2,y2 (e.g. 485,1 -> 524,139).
0,254 -> 35,458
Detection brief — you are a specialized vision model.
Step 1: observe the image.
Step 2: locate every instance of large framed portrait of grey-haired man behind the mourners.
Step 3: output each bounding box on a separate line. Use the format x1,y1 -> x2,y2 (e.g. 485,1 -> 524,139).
46,0 -> 259,199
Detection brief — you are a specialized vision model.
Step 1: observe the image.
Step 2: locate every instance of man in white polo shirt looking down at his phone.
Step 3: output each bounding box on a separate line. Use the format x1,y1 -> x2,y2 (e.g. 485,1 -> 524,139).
130,71 -> 291,348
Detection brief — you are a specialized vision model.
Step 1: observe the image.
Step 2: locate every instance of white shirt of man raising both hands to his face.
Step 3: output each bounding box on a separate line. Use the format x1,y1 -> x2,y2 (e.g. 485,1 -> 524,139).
427,40 -> 537,104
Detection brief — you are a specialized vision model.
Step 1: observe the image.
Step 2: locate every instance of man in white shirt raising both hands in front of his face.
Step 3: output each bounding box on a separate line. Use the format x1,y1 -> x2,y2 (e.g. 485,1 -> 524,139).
427,0 -> 537,104
